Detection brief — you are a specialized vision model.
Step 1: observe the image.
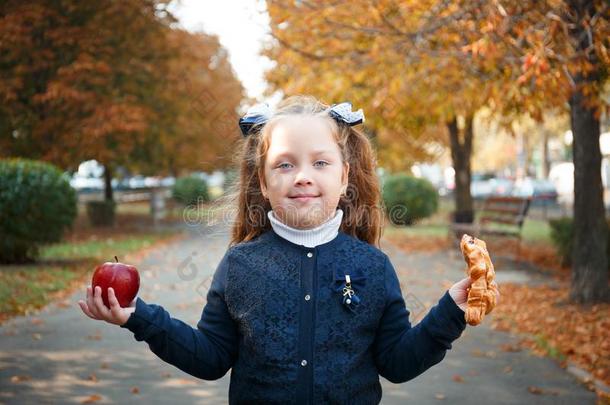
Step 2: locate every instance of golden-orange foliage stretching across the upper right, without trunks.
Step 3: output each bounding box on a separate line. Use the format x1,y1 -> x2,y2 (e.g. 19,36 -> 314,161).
265,0 -> 610,168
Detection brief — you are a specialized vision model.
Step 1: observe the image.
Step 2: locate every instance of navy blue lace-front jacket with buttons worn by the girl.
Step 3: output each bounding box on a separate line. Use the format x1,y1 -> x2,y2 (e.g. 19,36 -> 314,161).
121,229 -> 466,404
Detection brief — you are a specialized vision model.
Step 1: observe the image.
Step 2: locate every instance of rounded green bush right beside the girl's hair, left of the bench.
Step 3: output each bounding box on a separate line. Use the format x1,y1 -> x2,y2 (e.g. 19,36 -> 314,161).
382,173 -> 438,225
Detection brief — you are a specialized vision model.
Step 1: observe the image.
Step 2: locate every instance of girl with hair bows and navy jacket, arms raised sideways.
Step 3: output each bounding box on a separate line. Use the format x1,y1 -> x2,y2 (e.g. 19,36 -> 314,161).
79,96 -> 498,404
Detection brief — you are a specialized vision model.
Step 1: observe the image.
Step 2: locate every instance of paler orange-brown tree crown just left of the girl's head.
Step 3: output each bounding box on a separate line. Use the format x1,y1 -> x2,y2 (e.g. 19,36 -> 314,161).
134,29 -> 244,176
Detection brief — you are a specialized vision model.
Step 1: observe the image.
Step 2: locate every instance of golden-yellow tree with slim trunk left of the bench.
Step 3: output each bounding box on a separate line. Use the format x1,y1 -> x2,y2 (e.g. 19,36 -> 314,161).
267,0 -> 504,222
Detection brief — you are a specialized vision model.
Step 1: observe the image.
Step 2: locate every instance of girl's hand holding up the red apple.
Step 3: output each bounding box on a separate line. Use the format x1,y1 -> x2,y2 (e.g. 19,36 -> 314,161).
78,286 -> 137,326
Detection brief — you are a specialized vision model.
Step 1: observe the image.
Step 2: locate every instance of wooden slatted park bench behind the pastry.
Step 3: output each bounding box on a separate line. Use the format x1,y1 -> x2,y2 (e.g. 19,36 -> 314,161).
449,196 -> 531,259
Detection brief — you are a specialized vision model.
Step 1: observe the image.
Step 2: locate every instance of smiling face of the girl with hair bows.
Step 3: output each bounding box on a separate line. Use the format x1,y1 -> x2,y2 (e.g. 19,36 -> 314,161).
261,115 -> 349,229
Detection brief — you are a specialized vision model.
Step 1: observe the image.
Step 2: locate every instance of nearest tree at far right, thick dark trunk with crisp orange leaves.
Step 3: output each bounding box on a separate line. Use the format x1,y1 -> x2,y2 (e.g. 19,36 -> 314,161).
481,0 -> 610,303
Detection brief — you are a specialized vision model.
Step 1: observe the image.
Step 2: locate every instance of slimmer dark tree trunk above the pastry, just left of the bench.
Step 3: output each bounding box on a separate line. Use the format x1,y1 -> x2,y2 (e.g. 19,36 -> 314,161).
447,115 -> 474,223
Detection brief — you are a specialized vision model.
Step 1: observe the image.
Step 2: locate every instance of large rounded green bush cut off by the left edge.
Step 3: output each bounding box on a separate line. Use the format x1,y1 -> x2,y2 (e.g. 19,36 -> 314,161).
0,159 -> 77,263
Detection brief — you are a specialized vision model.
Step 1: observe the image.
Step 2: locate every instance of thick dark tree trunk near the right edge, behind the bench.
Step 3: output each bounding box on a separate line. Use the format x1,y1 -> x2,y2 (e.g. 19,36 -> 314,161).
570,1 -> 609,303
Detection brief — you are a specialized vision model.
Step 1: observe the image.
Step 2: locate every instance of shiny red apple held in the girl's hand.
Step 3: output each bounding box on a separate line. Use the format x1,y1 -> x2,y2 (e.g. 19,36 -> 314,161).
91,256 -> 140,308
